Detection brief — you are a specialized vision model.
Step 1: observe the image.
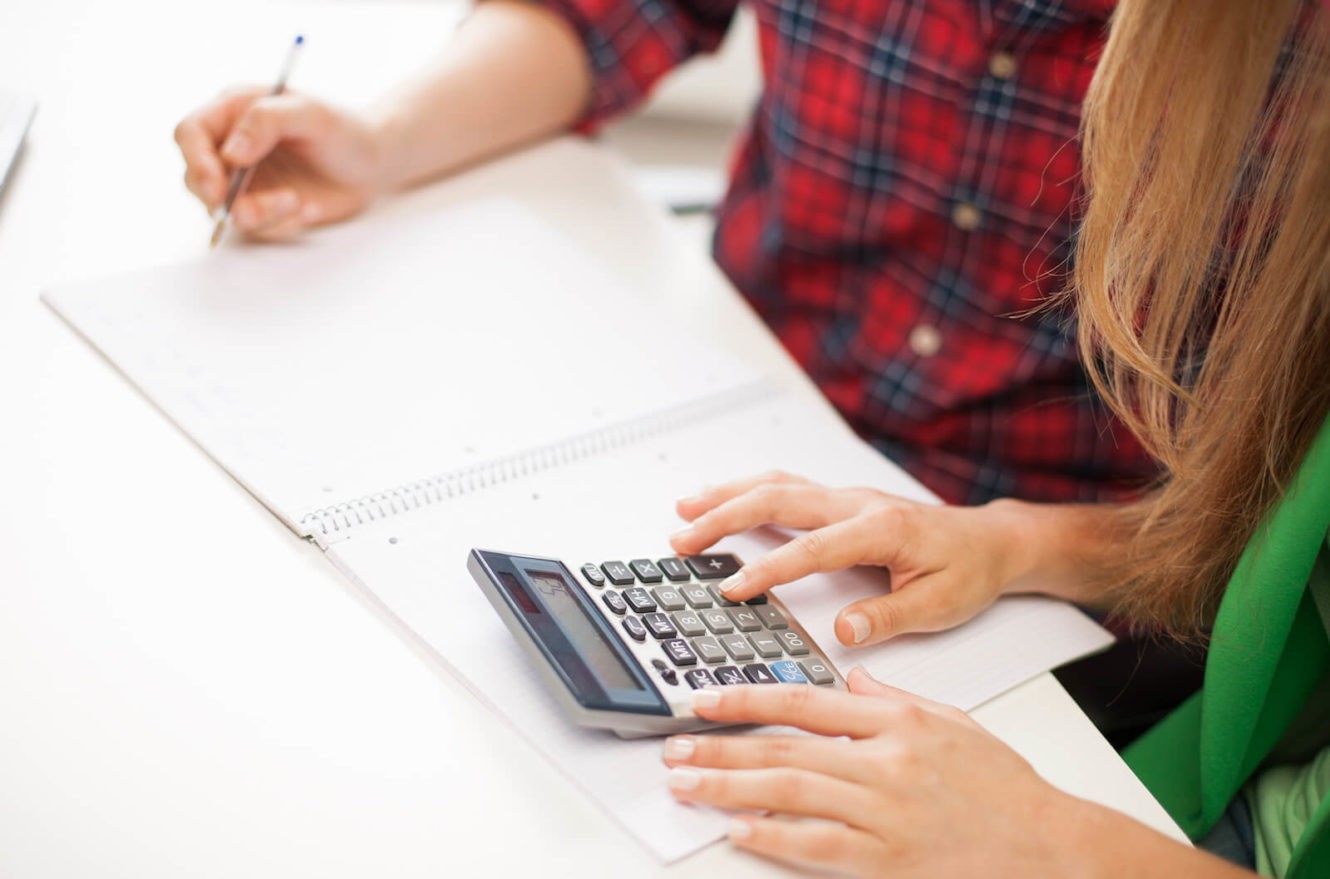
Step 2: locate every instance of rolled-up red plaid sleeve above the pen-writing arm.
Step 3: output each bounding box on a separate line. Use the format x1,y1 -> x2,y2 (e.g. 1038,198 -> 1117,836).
537,0 -> 738,129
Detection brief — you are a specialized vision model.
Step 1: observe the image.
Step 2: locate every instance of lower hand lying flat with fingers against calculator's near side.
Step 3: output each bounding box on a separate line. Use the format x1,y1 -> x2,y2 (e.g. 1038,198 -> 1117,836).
664,669 -> 1108,876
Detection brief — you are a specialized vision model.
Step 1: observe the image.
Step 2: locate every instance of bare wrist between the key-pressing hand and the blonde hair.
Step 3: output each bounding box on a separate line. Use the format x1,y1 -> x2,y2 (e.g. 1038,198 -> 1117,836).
983,500 -> 1132,609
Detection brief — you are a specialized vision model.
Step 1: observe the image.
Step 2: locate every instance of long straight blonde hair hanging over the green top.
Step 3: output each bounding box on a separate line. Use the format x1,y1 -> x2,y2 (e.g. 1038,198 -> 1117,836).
1072,0 -> 1330,637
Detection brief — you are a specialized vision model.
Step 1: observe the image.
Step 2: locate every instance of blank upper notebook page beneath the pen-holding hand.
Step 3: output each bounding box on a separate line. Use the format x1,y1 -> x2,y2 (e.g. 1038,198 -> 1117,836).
48,176 -> 758,524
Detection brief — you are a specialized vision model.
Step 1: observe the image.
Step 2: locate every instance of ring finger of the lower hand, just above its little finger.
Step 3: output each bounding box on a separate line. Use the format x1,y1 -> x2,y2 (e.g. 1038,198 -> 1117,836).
669,766 -> 875,826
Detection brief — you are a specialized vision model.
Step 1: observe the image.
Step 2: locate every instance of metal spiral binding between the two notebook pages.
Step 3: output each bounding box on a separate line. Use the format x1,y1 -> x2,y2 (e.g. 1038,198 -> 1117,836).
299,379 -> 777,537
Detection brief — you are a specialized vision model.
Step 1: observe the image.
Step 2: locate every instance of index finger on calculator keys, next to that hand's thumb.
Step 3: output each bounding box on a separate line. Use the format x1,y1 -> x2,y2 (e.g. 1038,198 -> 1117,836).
720,516 -> 890,601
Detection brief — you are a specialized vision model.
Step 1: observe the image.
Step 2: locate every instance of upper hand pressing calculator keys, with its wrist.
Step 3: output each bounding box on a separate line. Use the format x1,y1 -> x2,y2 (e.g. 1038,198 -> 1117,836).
670,472 -> 1117,645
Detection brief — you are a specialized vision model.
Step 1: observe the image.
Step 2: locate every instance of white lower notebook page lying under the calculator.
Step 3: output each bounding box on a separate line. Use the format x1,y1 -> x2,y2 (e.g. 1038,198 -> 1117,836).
316,392 -> 1112,862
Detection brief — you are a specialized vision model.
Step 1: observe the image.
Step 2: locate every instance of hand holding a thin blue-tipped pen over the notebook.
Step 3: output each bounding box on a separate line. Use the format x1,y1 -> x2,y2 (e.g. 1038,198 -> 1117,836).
176,37 -> 379,245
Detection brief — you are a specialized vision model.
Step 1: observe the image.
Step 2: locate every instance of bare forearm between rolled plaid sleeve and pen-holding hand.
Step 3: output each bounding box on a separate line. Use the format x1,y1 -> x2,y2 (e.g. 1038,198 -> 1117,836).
371,0 -> 592,190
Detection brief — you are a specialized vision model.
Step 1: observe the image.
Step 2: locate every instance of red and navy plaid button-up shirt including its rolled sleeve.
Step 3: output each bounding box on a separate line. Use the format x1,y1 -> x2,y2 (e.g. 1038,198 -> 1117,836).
544,0 -> 1154,503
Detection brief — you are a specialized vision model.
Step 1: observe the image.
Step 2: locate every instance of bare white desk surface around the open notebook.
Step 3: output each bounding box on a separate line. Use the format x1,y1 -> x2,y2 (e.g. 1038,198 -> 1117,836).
0,0 -> 1177,878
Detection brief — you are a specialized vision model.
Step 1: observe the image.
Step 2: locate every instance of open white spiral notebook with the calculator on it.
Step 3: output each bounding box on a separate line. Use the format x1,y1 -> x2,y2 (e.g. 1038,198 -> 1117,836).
44,140 -> 1111,860
